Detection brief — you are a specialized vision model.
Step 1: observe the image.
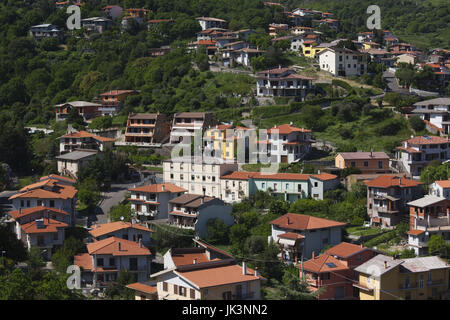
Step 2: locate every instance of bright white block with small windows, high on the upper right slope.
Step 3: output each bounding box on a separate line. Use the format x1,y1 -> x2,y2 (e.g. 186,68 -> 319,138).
319,47 -> 367,77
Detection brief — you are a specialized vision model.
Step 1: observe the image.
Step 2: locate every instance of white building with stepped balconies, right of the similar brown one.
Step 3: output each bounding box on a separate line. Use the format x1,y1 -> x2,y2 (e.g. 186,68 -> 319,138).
170,112 -> 216,143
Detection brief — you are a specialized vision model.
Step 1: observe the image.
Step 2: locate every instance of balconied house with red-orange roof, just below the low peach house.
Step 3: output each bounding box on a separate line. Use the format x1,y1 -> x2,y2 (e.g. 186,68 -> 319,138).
366,175 -> 423,227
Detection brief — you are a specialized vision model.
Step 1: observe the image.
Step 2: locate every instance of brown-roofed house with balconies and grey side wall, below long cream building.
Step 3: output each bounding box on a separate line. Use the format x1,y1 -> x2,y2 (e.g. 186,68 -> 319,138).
168,193 -> 234,238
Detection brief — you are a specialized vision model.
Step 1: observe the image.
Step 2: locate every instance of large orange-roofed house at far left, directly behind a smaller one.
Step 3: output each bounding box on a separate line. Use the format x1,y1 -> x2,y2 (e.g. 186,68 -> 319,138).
9,178 -> 78,226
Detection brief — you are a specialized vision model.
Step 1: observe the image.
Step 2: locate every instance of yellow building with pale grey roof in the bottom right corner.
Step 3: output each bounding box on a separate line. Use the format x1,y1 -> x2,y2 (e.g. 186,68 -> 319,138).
354,254 -> 450,300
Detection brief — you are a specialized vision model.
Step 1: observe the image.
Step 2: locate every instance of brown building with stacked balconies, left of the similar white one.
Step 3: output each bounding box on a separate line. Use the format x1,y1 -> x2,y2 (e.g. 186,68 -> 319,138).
125,113 -> 170,146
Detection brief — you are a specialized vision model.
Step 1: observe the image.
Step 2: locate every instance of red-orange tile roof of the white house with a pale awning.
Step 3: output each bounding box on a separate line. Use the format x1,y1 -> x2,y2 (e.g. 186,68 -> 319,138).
270,213 -> 347,230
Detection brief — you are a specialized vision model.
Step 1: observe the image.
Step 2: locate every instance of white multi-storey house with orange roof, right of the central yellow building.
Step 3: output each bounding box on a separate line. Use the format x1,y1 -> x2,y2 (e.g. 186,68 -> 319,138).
267,122 -> 311,163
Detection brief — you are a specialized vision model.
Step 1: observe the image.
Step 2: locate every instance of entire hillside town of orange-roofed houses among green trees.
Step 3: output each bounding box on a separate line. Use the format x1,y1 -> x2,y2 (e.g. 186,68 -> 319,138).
0,0 -> 450,300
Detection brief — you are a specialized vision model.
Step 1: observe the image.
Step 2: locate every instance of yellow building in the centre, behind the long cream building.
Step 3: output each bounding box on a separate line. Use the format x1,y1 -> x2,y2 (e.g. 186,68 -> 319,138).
205,124 -> 248,160
